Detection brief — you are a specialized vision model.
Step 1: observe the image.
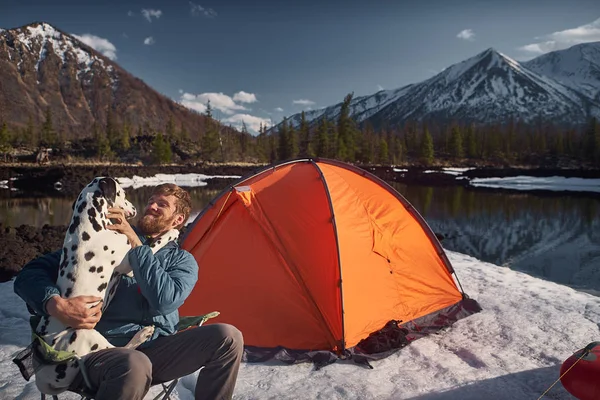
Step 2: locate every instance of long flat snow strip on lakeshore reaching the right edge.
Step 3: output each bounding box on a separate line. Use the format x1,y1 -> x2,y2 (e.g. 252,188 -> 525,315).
470,175 -> 600,193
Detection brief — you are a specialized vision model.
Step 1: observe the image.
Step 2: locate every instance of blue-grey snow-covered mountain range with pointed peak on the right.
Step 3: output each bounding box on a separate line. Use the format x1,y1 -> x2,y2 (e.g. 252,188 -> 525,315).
278,43 -> 600,131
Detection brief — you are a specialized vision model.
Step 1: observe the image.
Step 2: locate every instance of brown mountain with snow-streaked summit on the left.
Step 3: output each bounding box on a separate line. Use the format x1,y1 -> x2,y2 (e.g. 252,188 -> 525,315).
0,23 -> 210,137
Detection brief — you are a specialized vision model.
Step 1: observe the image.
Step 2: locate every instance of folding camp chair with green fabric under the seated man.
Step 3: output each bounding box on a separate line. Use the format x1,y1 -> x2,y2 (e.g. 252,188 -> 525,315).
13,311 -> 219,400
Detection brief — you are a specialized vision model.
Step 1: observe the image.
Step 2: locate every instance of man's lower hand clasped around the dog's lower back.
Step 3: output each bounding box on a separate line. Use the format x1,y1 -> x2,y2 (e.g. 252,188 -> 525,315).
46,296 -> 102,329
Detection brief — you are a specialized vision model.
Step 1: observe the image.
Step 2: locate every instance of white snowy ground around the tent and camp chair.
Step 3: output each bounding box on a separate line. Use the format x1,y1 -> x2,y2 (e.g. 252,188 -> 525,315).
0,252 -> 600,400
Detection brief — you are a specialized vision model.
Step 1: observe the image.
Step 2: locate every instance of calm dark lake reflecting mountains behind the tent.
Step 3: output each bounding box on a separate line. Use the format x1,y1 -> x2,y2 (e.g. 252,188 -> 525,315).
0,178 -> 600,295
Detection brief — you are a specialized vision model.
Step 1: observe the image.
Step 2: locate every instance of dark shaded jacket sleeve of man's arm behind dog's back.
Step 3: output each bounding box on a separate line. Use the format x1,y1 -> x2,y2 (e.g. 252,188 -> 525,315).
14,250 -> 61,316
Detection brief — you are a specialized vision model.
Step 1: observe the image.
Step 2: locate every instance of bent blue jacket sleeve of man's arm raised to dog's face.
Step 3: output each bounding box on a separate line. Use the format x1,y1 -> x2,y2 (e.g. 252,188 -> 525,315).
128,245 -> 198,315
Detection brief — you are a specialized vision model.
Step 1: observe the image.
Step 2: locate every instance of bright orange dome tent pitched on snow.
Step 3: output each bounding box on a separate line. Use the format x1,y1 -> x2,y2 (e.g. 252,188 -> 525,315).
179,159 -> 480,362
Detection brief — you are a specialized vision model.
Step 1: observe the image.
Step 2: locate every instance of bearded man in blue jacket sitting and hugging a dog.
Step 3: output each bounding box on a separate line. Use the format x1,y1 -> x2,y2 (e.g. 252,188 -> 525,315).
14,184 -> 243,400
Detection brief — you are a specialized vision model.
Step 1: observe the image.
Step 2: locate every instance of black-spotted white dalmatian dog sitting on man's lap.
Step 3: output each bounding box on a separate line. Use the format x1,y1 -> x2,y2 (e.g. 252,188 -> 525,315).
36,177 -> 179,395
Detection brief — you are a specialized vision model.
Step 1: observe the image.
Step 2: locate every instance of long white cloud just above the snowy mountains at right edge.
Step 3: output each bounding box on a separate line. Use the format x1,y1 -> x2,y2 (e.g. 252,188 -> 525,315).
518,18 -> 600,54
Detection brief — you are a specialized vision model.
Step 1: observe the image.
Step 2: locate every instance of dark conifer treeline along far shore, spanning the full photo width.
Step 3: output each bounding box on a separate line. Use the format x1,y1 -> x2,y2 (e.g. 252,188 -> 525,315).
0,94 -> 600,167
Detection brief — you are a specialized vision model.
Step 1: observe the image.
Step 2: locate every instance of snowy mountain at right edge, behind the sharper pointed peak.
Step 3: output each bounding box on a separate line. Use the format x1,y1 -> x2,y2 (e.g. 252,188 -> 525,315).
522,42 -> 600,101
